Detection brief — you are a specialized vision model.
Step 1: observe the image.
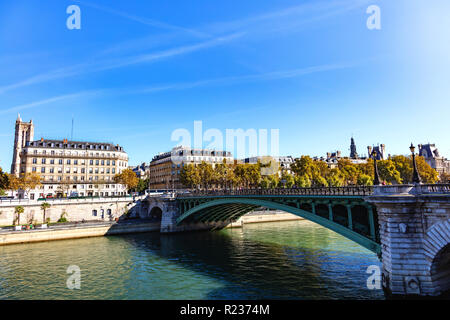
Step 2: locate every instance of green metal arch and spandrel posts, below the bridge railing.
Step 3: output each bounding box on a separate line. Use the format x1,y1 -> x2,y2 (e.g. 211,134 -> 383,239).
177,198 -> 381,254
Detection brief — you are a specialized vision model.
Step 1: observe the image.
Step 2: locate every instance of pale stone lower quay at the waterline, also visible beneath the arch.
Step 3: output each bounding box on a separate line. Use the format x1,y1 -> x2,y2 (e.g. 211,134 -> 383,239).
0,211 -> 302,245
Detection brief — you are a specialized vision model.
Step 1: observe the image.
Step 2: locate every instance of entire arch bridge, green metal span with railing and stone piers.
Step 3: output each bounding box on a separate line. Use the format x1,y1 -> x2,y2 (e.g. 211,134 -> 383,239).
147,184 -> 450,296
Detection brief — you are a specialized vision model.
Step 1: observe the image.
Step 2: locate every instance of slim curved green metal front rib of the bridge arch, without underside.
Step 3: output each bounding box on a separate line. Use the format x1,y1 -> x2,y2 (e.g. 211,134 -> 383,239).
177,198 -> 381,254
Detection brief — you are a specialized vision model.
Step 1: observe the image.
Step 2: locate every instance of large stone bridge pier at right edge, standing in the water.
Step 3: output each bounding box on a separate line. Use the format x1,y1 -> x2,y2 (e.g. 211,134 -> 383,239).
366,185 -> 450,296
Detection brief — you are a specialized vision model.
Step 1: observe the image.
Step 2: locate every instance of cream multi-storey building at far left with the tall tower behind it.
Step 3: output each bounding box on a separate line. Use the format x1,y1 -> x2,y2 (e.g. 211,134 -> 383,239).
11,115 -> 128,199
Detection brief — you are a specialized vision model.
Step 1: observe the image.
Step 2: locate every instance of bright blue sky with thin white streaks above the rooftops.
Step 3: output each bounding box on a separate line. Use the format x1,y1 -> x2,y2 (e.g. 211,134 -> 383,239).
0,0 -> 450,171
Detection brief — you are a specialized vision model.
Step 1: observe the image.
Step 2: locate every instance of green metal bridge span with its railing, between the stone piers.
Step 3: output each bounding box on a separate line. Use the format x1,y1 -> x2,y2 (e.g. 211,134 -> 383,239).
176,186 -> 381,254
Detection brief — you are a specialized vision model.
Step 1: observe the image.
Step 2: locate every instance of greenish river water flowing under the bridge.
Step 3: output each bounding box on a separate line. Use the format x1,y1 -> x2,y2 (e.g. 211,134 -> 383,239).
0,221 -> 384,299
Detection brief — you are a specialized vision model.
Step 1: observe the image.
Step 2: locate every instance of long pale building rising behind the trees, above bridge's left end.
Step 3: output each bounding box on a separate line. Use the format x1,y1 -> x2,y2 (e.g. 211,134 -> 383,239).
150,147 -> 234,189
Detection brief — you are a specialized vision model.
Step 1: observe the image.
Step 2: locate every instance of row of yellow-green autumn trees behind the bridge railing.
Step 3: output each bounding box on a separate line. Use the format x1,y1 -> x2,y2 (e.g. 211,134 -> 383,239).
180,156 -> 439,189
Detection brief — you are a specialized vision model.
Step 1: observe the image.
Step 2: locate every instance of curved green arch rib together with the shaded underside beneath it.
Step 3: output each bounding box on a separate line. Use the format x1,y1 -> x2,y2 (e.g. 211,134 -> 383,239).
176,198 -> 381,254
